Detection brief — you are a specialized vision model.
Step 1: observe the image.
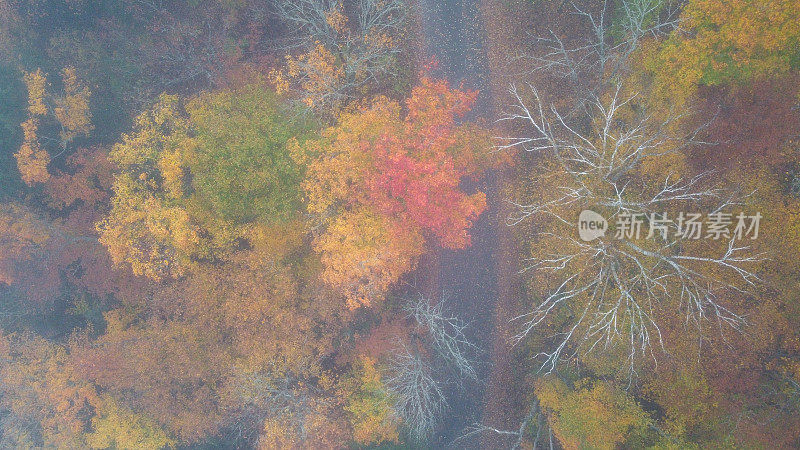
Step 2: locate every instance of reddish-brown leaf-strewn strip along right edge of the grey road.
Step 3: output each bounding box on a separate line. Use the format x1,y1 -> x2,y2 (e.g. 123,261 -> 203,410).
481,0 -> 584,449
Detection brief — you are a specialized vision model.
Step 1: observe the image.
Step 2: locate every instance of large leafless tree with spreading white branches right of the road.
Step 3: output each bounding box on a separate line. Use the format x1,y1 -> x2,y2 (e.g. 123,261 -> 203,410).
500,78 -> 763,374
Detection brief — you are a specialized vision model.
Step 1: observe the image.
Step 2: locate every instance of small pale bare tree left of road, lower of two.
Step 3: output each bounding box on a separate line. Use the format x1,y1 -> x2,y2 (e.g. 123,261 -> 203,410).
386,346 -> 447,442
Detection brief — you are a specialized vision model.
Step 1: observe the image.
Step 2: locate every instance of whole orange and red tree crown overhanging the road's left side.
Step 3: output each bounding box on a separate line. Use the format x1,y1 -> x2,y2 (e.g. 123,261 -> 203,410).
293,75 -> 489,308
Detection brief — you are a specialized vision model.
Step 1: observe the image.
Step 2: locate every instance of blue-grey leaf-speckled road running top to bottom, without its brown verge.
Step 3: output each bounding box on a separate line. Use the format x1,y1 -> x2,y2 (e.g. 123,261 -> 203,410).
419,0 -> 499,448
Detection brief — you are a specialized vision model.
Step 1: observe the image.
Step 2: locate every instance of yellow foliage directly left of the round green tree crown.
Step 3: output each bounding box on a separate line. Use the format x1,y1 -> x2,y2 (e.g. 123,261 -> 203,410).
97,95 -> 233,279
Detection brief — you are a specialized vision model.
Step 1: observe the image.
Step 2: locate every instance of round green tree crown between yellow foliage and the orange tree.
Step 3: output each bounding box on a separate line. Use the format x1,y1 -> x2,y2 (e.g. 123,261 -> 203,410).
186,82 -> 309,223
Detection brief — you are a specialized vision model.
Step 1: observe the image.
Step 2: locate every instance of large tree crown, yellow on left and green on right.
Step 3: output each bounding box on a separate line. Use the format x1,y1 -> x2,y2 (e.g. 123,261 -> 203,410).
98,79 -> 310,279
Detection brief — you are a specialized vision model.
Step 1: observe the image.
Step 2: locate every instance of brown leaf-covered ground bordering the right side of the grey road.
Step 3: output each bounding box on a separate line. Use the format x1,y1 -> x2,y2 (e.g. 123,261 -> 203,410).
456,0 -> 584,449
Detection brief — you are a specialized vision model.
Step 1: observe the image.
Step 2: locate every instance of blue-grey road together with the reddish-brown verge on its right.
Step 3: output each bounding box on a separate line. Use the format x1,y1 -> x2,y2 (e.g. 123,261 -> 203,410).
417,0 -> 582,448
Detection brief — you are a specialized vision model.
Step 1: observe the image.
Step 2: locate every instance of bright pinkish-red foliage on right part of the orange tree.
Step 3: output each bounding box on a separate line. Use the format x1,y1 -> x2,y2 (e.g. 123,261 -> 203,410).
367,76 -> 488,249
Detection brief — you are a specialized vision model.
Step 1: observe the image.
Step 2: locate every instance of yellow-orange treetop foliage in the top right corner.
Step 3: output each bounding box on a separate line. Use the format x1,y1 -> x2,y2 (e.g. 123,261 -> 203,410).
646,0 -> 800,99
